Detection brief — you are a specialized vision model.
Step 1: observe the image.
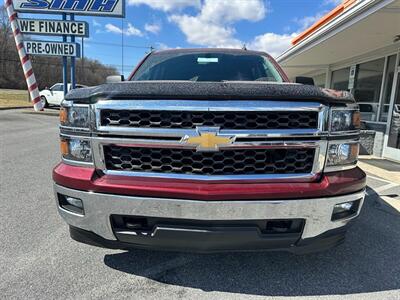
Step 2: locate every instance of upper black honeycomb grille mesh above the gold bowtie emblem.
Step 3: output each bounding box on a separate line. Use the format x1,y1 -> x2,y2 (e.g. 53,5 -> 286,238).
100,109 -> 318,130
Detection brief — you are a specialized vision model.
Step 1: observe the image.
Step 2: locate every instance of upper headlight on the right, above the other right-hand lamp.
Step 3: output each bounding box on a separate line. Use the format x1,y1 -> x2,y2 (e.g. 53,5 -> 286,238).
330,109 -> 361,133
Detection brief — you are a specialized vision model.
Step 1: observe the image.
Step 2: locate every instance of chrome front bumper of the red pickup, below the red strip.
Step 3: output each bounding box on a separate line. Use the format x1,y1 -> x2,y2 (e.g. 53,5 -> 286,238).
54,183 -> 365,240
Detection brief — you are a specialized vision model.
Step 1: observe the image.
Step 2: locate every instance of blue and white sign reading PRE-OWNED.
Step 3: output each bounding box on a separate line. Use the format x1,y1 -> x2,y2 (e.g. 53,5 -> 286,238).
24,41 -> 80,57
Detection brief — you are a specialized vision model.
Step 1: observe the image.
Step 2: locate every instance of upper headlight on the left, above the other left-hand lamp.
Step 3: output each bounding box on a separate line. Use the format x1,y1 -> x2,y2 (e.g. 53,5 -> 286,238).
60,105 -> 89,128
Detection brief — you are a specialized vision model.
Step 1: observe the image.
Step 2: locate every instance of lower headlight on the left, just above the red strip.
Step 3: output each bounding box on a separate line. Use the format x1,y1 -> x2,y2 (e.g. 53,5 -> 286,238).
60,137 -> 93,163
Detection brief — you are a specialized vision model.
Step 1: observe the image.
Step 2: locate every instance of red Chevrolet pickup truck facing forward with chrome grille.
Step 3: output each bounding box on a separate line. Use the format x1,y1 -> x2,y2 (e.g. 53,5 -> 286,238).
53,49 -> 365,253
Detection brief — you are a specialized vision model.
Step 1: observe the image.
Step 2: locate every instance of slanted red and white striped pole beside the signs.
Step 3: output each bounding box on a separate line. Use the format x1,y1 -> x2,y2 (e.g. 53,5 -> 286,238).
4,0 -> 44,111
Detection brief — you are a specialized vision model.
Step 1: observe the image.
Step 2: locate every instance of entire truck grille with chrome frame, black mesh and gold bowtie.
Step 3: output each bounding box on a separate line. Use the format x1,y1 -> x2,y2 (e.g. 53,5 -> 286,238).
92,99 -> 329,182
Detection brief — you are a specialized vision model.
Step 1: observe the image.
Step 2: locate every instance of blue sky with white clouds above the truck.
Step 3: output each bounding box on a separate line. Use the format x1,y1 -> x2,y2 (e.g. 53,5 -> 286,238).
23,0 -> 342,75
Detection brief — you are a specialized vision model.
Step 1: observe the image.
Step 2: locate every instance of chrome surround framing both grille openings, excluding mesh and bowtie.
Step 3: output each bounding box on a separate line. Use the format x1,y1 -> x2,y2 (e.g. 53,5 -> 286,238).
92,100 -> 329,181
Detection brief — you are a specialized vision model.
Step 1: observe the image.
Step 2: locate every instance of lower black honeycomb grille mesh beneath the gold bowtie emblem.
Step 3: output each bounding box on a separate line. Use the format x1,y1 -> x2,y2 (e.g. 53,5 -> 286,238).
103,145 -> 315,175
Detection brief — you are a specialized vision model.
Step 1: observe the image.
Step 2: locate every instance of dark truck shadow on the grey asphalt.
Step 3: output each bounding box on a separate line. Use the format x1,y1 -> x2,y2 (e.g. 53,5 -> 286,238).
104,189 -> 400,296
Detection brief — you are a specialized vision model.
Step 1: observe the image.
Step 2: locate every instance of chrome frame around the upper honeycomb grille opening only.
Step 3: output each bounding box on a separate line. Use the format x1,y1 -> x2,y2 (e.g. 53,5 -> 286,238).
95,100 -> 328,137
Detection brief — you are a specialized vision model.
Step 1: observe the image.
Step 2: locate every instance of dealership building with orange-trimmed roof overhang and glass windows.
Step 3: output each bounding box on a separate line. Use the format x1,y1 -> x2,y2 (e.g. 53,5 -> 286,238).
278,0 -> 400,161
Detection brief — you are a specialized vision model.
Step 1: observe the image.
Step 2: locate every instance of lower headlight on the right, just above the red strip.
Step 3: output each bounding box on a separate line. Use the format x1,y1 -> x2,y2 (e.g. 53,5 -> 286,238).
326,142 -> 360,171
